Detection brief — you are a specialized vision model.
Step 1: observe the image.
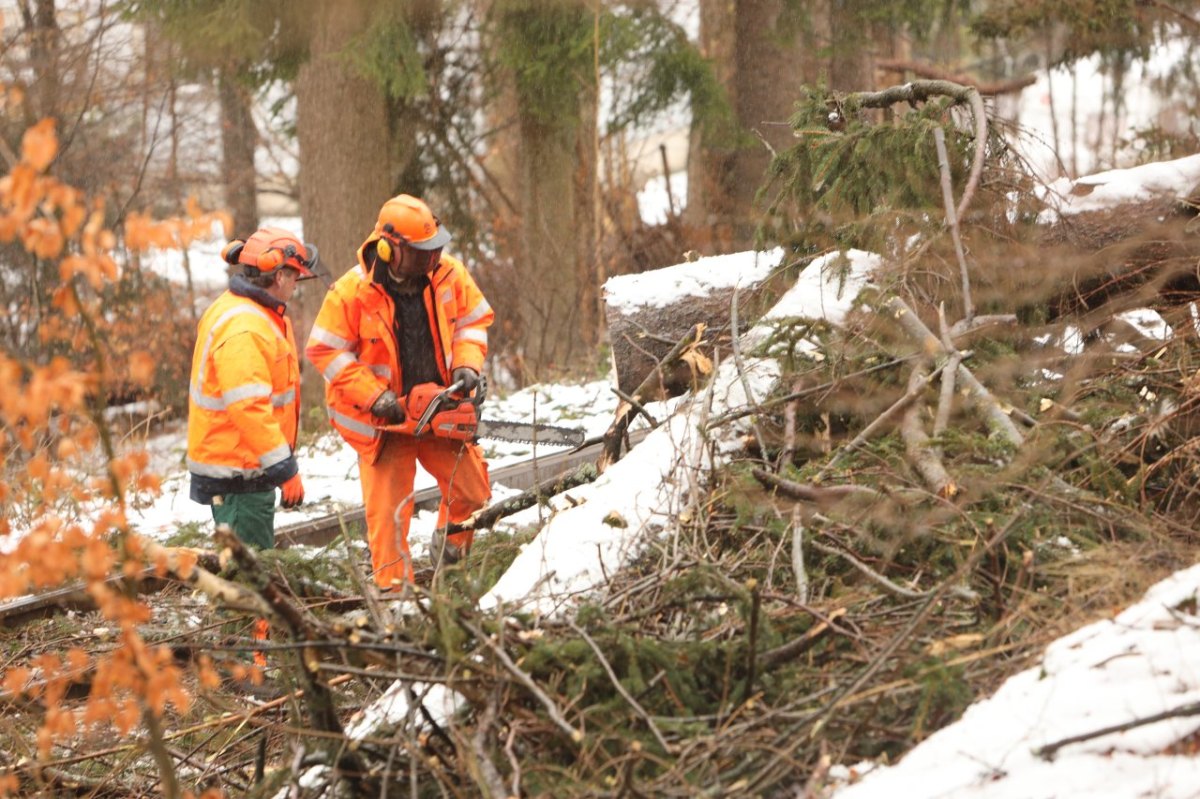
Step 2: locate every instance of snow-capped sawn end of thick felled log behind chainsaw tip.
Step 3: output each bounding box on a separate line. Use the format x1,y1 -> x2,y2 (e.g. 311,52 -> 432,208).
604,250 -> 782,402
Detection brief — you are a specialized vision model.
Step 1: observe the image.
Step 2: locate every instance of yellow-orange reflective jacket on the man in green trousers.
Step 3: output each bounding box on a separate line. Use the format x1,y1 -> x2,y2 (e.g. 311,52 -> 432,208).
187,276 -> 300,504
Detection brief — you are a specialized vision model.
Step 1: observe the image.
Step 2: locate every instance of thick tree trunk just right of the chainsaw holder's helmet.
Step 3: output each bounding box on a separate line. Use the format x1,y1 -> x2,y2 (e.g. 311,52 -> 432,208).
491,2 -> 602,382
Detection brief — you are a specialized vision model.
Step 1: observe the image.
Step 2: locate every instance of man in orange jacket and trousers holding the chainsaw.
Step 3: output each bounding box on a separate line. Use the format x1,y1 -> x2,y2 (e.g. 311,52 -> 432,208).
305,194 -> 494,590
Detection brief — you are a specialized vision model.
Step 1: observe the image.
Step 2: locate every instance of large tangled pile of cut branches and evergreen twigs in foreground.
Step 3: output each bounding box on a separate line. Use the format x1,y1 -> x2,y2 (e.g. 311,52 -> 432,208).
2,257 -> 1200,797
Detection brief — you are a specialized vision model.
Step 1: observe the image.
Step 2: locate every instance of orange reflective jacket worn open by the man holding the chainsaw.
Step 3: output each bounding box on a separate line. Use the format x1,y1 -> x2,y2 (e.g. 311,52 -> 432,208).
305,248 -> 496,463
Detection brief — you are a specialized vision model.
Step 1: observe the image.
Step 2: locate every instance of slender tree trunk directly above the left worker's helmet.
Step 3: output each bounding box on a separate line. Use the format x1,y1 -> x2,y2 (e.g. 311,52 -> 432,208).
217,64 -> 258,236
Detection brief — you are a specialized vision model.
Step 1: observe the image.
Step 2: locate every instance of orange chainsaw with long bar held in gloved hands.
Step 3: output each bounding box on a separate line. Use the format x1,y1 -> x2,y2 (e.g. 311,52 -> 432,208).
383,376 -> 584,447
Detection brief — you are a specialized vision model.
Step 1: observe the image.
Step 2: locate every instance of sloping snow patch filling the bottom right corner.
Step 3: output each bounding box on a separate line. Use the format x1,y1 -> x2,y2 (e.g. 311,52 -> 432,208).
834,566 -> 1200,799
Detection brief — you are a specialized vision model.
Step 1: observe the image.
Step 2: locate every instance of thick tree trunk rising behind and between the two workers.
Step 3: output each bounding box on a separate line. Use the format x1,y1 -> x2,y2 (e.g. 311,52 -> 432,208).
290,0 -> 394,409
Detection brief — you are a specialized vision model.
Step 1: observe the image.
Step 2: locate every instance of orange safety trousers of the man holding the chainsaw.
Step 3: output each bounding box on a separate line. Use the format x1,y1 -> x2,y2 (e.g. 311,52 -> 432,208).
359,433 -> 492,589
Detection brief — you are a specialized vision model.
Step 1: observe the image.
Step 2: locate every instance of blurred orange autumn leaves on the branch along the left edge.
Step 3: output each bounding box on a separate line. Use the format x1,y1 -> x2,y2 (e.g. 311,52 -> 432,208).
0,112 -> 229,795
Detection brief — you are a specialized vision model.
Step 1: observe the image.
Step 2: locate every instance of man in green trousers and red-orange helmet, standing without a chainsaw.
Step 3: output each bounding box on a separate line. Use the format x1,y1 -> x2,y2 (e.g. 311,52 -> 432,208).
187,228 -> 317,666
